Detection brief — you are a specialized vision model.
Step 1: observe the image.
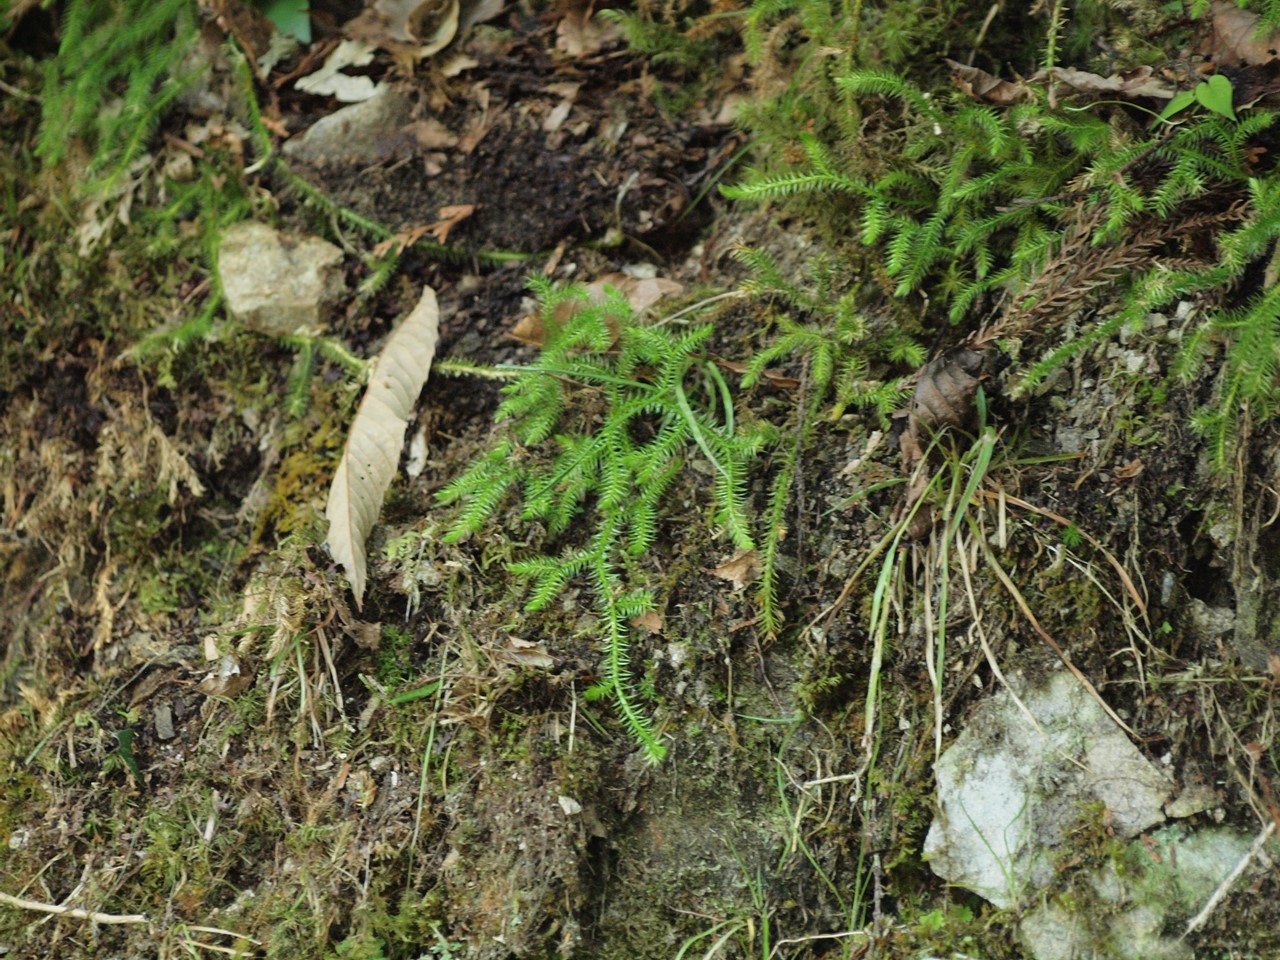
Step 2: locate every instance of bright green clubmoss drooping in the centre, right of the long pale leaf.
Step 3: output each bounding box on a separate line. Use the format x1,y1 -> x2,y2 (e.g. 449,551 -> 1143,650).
438,278 -> 774,762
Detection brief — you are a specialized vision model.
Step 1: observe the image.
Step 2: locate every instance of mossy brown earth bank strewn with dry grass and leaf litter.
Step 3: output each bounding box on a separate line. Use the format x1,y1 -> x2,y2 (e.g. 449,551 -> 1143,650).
0,4 -> 1280,960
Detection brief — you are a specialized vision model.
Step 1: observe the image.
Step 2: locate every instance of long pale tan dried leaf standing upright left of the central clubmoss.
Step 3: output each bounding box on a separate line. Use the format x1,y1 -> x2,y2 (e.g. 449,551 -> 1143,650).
325,287 -> 440,609
